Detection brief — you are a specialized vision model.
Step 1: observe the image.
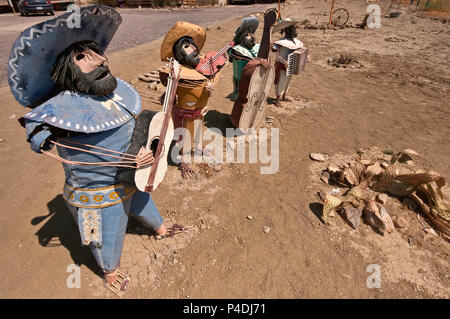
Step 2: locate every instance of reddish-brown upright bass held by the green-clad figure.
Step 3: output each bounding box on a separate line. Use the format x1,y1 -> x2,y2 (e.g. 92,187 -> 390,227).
230,9 -> 278,131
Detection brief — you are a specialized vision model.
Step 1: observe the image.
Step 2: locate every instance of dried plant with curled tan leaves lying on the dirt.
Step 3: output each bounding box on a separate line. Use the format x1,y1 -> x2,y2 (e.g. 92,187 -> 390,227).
323,149 -> 450,237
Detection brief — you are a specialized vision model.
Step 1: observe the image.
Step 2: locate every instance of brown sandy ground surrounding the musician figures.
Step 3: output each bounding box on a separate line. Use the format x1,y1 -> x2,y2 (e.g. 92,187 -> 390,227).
0,0 -> 450,298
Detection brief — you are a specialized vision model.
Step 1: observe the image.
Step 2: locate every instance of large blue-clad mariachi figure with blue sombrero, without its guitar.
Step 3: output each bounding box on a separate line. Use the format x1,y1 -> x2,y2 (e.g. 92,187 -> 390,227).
8,5 -> 182,294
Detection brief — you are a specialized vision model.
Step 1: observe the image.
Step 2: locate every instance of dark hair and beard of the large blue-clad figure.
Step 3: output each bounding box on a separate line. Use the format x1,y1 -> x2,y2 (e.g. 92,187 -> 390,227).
50,41 -> 117,96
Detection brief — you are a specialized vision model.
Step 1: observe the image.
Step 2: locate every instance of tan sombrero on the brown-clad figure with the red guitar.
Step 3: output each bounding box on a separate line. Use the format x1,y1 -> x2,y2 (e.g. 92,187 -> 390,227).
161,21 -> 206,61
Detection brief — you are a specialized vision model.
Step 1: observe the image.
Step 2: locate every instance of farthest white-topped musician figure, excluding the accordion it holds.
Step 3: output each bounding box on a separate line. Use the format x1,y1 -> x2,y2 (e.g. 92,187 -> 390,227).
272,18 -> 310,107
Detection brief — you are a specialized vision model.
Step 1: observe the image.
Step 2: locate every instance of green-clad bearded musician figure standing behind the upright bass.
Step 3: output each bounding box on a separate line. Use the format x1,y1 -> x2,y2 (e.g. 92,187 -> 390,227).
228,16 -> 259,101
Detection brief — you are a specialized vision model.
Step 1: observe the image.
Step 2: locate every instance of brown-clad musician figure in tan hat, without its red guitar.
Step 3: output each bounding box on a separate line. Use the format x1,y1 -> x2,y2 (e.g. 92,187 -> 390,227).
160,21 -> 226,178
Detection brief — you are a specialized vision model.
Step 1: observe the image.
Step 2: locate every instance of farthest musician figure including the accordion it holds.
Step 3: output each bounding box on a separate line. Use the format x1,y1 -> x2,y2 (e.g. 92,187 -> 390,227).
272,18 -> 310,107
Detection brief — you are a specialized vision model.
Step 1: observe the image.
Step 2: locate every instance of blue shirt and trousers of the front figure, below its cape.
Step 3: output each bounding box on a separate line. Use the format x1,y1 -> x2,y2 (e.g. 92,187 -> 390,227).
53,119 -> 163,271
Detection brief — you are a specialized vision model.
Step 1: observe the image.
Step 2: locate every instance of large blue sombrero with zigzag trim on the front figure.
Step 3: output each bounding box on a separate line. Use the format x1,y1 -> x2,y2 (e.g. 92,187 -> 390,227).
8,5 -> 122,107
